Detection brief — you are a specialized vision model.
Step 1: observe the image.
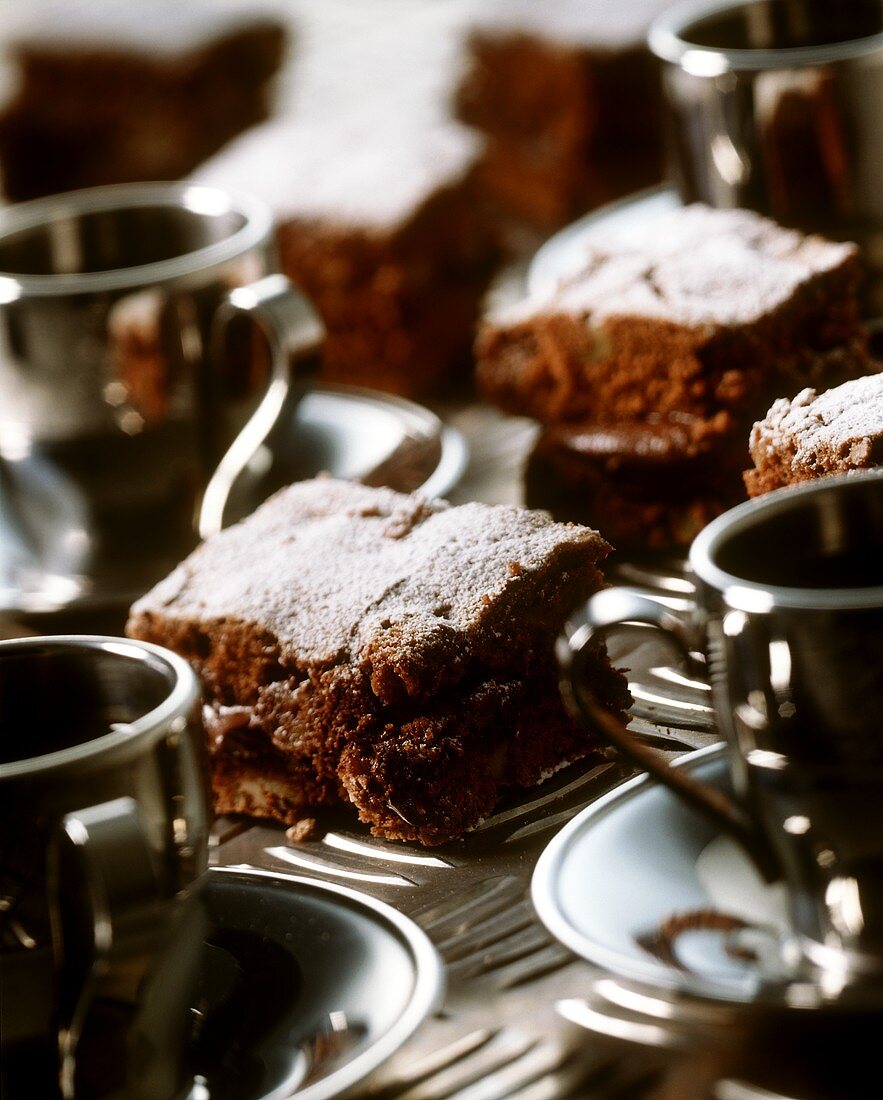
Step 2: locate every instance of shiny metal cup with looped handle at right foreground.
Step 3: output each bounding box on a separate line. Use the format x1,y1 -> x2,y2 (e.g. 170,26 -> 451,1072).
559,471 -> 883,983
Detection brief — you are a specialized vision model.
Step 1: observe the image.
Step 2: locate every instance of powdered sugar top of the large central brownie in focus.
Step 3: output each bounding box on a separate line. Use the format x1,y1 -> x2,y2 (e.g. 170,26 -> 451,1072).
132,479 -> 609,668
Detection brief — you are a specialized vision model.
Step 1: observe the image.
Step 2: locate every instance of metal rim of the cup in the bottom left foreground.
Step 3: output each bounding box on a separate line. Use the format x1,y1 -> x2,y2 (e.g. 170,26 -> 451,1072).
0,635 -> 200,782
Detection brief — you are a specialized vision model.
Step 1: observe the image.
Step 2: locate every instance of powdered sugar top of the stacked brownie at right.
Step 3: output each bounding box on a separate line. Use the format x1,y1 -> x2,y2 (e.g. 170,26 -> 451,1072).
490,204 -> 858,328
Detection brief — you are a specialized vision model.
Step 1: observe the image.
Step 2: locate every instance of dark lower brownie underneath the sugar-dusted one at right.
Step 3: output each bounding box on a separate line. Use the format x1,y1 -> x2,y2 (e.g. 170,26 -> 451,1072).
525,418 -> 744,554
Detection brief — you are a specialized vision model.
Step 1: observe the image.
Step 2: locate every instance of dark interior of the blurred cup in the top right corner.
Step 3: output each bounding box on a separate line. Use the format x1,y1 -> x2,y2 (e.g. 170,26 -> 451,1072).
681,0 -> 883,50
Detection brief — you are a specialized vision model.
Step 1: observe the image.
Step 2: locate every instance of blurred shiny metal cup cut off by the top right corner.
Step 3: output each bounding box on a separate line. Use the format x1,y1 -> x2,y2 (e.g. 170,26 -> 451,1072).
649,0 -> 883,305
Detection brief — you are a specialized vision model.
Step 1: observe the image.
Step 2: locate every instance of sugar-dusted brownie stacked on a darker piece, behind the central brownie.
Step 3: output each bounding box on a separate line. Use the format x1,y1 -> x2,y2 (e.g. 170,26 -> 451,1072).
476,205 -> 869,424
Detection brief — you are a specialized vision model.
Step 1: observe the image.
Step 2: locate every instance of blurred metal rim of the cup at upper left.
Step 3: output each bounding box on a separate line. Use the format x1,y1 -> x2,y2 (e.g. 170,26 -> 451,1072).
0,182 -> 274,305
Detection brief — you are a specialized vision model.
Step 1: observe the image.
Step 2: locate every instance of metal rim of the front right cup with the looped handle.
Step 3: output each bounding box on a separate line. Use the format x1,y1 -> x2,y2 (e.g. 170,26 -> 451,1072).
688,470 -> 883,613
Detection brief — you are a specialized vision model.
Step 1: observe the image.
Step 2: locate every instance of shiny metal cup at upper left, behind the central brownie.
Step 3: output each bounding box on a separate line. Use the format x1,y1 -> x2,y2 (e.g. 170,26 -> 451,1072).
0,183 -> 322,613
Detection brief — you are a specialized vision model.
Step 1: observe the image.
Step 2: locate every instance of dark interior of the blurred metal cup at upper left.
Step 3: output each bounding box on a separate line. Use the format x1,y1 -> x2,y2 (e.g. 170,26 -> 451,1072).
0,202 -> 246,275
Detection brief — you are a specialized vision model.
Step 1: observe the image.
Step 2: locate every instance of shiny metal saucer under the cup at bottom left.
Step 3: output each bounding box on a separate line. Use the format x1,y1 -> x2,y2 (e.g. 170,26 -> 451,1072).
134,868 -> 443,1100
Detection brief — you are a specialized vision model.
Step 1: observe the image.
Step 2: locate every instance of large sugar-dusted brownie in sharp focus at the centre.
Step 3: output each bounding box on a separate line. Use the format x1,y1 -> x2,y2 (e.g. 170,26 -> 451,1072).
129,479 -> 628,844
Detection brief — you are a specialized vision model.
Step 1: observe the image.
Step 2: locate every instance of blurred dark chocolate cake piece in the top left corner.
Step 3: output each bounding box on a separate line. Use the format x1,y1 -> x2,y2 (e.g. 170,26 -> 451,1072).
0,0 -> 287,200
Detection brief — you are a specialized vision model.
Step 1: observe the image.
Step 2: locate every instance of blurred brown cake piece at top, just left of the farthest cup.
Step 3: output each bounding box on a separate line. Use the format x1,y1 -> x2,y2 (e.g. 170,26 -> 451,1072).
456,0 -> 670,229
